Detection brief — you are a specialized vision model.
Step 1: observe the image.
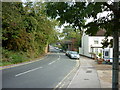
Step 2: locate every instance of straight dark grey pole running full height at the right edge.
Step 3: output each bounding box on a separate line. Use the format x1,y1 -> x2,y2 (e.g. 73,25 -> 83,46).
112,2 -> 119,90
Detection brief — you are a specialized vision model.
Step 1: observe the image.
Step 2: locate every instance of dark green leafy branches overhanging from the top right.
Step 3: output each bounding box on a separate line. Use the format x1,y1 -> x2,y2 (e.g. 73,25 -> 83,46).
47,2 -> 120,36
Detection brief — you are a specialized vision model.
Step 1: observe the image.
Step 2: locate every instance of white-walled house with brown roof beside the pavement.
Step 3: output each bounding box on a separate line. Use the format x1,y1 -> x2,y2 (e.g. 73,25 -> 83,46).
79,29 -> 113,58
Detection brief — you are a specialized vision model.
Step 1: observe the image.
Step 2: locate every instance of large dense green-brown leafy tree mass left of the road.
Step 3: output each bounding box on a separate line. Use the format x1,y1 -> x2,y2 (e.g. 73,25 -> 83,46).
2,2 -> 57,57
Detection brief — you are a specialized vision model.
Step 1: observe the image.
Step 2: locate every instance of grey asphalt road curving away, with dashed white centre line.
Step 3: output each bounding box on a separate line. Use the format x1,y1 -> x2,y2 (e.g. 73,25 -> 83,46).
2,46 -> 77,88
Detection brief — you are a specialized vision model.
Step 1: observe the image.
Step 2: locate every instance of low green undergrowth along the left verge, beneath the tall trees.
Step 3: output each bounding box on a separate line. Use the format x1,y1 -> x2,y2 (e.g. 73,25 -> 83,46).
0,48 -> 43,66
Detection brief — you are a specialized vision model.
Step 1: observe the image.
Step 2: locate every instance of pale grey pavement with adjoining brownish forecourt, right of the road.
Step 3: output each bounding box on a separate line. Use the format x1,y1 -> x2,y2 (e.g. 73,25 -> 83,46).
67,56 -> 120,89
